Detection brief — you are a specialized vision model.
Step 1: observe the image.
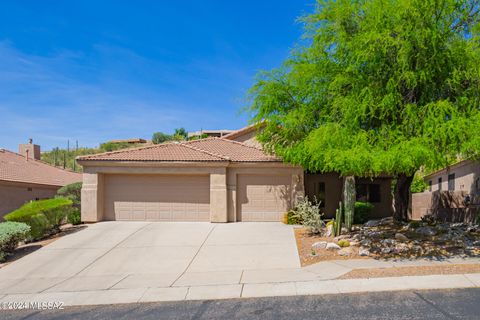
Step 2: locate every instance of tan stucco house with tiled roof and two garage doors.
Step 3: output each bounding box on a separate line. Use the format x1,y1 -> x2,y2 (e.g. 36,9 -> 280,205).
77,127 -> 391,222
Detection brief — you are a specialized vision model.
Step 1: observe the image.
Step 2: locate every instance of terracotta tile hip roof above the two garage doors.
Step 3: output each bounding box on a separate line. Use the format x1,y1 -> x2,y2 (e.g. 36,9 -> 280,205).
77,138 -> 280,162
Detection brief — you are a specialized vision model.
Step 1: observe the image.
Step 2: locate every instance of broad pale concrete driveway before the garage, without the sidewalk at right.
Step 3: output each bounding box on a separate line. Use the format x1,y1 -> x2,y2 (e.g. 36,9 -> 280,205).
0,221 -> 300,303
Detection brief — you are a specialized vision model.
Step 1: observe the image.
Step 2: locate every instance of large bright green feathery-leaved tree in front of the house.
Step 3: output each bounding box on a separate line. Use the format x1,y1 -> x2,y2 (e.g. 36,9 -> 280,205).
250,0 -> 480,220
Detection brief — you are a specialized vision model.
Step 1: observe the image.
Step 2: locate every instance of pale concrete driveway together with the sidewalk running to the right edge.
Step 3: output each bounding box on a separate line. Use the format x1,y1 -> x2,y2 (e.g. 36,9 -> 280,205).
0,222 -> 480,305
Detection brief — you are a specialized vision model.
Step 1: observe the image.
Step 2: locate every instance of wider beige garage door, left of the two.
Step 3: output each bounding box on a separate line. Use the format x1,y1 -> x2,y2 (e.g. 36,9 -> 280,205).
105,174 -> 210,221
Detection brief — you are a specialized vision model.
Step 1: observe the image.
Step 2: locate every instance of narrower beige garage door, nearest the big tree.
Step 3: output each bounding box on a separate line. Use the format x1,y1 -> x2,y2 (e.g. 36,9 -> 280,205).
237,174 -> 291,221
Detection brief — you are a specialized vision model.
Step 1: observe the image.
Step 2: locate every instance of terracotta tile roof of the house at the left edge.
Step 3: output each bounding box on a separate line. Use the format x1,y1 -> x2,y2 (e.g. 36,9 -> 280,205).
0,149 -> 82,186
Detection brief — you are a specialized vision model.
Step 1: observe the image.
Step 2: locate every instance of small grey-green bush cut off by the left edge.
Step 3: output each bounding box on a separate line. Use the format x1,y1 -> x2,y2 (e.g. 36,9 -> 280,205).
0,222 -> 30,261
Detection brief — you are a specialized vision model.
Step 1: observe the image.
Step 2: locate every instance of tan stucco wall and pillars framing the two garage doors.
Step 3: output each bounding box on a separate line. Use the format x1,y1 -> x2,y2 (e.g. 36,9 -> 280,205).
81,162 -> 303,222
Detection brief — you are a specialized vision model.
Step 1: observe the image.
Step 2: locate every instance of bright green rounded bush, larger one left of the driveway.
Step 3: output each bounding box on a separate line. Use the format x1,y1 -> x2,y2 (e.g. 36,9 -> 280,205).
3,198 -> 72,239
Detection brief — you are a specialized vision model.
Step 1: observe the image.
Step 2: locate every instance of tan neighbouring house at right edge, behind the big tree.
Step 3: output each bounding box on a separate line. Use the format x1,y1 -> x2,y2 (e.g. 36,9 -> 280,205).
412,160 -> 480,222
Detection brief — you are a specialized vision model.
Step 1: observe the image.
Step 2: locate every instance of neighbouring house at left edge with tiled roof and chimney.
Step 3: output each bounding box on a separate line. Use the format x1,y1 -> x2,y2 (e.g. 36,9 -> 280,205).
0,140 -> 82,218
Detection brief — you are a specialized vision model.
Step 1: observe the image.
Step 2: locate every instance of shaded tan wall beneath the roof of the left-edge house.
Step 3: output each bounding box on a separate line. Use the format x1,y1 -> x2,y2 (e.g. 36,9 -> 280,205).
0,181 -> 60,218
